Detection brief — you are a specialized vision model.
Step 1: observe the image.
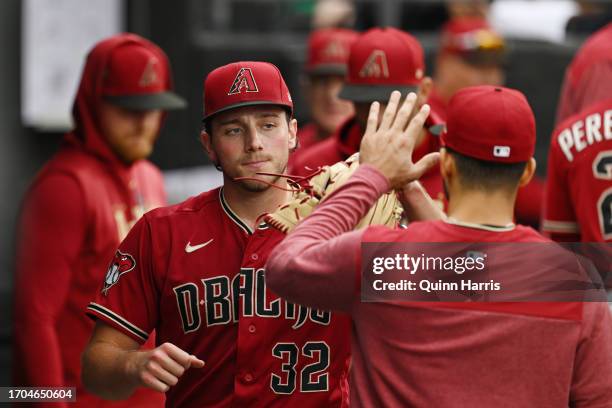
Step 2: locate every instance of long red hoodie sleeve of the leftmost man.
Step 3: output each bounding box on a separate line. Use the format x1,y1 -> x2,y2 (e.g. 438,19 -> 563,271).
13,174 -> 87,387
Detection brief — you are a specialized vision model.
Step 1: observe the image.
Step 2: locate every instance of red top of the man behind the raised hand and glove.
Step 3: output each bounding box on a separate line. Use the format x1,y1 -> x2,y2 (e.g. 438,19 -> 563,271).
289,118 -> 444,201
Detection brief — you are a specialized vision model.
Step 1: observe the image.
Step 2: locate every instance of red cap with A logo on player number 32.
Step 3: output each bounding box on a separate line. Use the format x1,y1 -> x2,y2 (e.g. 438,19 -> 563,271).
204,61 -> 293,120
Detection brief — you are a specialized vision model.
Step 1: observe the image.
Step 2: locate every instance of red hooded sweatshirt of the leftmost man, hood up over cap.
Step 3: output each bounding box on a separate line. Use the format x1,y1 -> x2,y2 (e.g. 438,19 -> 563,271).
13,34 -> 170,407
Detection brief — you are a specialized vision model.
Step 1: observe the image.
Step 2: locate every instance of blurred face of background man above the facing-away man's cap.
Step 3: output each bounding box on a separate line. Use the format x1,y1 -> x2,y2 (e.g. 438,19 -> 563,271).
436,55 -> 505,98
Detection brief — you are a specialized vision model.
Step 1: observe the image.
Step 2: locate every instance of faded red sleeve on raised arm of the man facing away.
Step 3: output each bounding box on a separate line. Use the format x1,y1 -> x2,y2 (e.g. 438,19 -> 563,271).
266,165 -> 389,312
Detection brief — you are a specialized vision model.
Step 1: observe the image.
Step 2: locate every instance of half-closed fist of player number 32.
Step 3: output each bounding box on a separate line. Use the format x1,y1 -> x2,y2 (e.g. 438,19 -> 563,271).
130,343 -> 204,392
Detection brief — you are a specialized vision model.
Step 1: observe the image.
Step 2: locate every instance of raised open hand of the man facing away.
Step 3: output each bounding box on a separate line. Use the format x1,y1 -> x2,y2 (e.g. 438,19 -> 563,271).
359,91 -> 439,188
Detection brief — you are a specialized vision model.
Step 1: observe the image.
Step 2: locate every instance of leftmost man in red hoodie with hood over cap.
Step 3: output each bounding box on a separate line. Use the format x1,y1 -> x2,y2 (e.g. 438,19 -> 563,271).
13,34 -> 185,407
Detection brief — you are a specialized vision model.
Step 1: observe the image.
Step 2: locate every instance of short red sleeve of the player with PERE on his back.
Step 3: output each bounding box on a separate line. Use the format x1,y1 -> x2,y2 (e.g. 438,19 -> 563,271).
542,140 -> 580,241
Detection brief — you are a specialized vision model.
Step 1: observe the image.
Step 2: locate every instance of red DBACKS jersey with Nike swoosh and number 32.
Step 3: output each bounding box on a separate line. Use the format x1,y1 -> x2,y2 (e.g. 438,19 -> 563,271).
88,189 -> 350,407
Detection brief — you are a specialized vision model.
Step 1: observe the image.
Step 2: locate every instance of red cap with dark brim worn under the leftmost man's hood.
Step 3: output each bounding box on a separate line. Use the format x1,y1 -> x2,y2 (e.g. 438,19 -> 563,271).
102,42 -> 186,110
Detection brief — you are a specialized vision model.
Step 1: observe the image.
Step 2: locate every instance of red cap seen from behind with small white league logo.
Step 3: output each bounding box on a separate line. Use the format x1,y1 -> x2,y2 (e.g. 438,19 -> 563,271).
441,85 -> 536,163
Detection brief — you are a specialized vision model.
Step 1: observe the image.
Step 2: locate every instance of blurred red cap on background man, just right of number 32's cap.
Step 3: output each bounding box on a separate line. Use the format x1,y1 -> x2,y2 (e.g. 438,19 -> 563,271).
306,28 -> 359,75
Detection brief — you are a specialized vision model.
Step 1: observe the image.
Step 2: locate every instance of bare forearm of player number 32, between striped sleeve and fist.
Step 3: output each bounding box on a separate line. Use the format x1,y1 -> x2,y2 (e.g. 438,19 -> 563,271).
81,342 -> 142,400
